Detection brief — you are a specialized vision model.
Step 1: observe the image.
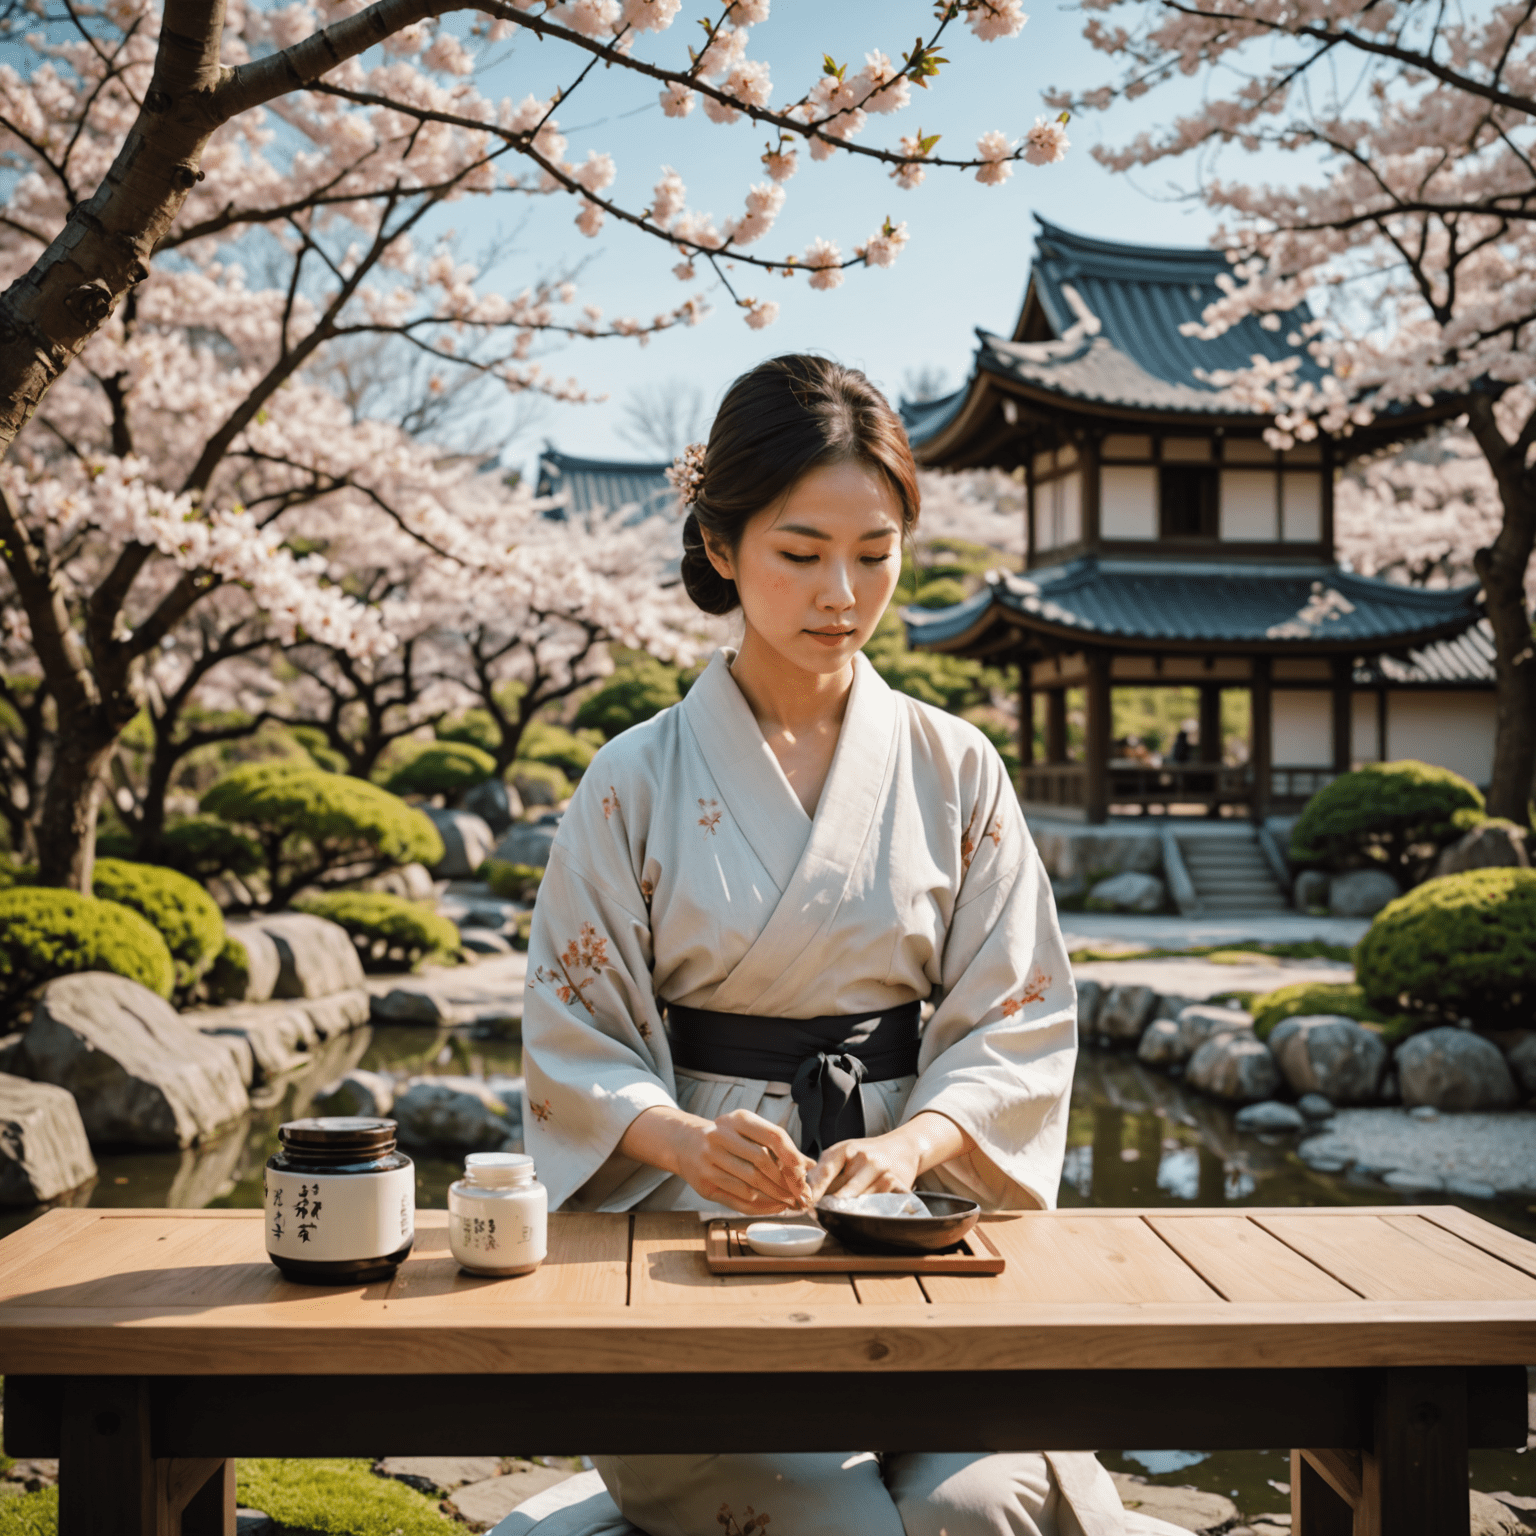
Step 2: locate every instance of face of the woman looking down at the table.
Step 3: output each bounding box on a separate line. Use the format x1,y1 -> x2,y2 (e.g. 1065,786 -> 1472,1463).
705,451 -> 902,674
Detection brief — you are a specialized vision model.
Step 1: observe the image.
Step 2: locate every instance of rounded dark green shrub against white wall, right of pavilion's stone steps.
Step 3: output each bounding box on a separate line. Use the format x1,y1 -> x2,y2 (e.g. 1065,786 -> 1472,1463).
1290,759 -> 1484,885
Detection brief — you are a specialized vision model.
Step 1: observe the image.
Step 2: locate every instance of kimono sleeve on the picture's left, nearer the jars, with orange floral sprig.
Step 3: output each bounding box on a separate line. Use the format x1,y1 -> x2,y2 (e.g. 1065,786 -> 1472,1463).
522,790 -> 677,1210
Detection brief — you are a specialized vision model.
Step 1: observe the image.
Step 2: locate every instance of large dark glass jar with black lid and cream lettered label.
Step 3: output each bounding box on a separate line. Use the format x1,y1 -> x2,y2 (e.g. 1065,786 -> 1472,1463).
261,1115 -> 416,1286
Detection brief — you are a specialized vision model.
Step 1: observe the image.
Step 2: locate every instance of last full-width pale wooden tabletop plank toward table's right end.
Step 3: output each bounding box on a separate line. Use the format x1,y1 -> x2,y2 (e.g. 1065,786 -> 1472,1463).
1253,1212 -> 1536,1301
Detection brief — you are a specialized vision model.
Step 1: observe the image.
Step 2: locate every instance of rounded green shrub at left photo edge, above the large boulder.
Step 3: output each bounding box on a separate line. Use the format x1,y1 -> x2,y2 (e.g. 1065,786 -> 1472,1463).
0,886 -> 177,1012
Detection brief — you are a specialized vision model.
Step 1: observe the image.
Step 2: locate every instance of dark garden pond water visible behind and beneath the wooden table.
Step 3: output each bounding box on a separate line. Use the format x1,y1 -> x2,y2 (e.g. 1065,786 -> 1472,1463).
0,1026 -> 1536,1516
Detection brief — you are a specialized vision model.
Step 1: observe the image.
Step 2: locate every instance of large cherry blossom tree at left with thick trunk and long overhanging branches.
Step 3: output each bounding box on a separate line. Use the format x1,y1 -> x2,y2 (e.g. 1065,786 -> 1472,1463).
0,0 -> 1066,889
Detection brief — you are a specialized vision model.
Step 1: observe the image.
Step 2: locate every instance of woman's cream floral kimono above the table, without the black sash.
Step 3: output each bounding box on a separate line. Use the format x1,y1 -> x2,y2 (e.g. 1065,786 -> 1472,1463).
522,651 -> 1077,1210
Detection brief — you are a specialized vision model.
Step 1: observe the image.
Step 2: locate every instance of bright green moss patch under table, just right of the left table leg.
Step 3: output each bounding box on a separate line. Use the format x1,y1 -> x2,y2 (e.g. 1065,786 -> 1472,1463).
233,1459 -> 462,1536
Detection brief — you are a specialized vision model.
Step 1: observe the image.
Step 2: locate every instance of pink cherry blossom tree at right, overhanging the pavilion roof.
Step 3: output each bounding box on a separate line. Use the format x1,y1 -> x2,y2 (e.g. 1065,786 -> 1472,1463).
1051,0 -> 1536,820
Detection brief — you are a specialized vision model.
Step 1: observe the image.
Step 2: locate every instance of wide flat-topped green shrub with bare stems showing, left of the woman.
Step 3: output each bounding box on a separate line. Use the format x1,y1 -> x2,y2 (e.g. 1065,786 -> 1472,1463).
203,762 -> 442,909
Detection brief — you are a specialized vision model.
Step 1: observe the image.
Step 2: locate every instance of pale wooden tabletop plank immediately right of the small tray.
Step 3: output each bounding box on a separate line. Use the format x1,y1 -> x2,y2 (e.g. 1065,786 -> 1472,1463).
923,1210 -> 1221,1304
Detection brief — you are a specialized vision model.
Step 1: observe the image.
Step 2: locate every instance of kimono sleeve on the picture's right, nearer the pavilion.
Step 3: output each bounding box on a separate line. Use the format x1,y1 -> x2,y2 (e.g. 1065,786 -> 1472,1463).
903,753 -> 1077,1210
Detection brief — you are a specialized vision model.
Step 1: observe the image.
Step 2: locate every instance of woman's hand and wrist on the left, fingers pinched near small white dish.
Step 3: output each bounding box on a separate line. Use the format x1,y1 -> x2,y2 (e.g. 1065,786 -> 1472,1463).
619,1104 -> 816,1217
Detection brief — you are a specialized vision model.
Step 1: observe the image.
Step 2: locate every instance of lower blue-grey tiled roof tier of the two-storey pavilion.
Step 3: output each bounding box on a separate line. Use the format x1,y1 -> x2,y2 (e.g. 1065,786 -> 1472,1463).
905,556 -> 1478,653
